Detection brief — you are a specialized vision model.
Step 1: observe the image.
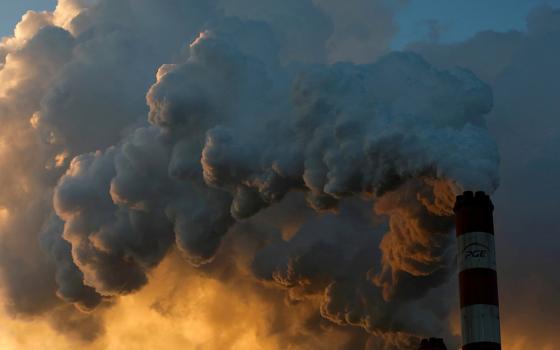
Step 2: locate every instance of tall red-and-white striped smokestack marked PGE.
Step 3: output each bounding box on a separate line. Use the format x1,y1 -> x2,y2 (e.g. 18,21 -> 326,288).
453,191 -> 501,350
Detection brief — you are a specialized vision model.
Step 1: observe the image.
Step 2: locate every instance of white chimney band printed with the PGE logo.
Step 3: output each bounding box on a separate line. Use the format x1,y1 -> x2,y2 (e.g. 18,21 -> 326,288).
457,232 -> 496,271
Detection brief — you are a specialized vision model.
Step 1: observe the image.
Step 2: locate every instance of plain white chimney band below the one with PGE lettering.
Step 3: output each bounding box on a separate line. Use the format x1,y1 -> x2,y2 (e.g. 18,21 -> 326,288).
461,304 -> 500,345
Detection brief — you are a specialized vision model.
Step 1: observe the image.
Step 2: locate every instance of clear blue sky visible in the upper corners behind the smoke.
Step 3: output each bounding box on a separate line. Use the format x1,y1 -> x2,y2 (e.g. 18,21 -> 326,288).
0,0 -> 560,45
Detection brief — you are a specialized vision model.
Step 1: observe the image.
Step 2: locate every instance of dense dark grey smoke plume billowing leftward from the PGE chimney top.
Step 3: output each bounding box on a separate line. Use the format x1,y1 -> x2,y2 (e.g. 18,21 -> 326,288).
54,23 -> 498,348
